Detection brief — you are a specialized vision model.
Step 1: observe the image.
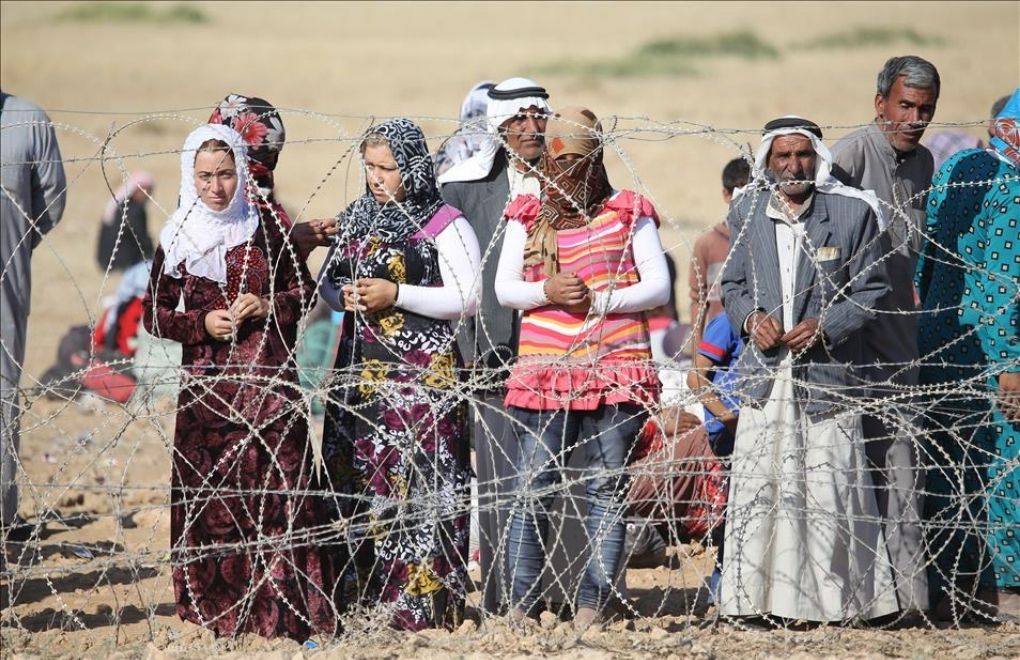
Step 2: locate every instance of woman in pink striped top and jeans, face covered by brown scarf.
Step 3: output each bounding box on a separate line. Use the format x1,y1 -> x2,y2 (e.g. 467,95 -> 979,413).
496,108 -> 669,627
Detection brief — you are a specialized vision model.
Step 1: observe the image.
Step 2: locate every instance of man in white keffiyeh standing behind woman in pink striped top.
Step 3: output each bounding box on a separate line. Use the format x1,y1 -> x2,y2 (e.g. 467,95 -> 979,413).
439,78 -> 550,613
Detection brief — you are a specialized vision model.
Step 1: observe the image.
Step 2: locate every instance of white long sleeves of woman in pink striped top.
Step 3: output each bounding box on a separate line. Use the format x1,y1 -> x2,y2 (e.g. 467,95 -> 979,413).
496,217 -> 670,315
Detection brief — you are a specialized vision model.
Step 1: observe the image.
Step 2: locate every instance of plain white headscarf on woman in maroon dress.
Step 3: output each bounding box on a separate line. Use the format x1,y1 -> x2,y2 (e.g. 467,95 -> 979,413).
159,123 -> 259,284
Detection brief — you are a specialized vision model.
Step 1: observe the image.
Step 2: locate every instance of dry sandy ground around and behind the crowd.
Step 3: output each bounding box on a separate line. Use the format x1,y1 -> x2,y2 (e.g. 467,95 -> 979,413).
0,2 -> 1020,658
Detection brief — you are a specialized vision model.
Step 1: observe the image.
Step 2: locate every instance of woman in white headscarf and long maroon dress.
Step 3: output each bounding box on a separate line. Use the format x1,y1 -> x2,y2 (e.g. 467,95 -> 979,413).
143,124 -> 337,642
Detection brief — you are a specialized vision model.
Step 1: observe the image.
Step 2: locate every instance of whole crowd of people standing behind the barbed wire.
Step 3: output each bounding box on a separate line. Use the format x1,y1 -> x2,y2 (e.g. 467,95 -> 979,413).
0,56 -> 1020,641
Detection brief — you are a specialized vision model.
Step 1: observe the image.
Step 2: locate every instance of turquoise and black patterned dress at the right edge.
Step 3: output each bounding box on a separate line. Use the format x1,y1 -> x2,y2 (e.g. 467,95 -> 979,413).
917,149 -> 1020,604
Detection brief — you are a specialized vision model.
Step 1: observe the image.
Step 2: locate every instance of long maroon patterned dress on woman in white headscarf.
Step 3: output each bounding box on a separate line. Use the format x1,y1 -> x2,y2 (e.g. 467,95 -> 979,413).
145,219 -> 337,641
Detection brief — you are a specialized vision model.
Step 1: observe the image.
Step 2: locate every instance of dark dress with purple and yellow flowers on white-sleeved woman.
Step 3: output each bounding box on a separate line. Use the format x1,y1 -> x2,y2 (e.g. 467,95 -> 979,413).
323,224 -> 470,630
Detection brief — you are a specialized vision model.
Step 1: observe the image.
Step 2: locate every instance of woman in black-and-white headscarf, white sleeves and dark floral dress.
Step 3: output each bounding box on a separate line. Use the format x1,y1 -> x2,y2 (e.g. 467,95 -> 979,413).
320,119 -> 479,630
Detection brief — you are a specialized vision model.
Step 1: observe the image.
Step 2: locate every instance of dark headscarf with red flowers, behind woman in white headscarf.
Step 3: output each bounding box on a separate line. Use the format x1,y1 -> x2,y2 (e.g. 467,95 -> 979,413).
209,94 -> 287,195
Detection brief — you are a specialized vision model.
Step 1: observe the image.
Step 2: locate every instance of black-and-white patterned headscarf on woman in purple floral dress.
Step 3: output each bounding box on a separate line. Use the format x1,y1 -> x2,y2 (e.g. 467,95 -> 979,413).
337,118 -> 443,245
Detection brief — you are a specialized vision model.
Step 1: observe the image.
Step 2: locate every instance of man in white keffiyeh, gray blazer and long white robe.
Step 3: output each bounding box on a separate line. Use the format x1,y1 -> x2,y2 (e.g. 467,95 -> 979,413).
719,116 -> 899,621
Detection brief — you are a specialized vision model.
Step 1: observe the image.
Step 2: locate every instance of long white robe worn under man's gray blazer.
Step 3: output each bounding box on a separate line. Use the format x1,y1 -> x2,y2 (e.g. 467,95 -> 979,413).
719,210 -> 899,621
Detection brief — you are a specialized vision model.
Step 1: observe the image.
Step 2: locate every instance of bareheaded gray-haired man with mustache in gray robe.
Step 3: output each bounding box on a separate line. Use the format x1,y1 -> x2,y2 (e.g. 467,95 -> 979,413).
832,55 -> 940,613
